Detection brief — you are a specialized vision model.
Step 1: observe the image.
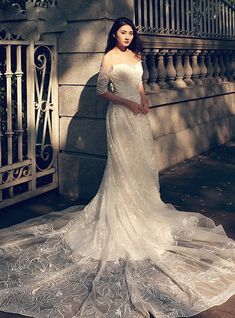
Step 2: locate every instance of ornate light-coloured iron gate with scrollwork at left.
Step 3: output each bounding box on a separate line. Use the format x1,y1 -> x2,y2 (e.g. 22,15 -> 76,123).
0,41 -> 58,208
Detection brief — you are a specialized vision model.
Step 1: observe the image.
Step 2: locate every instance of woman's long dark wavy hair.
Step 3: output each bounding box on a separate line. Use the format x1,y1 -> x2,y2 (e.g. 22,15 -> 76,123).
105,17 -> 143,55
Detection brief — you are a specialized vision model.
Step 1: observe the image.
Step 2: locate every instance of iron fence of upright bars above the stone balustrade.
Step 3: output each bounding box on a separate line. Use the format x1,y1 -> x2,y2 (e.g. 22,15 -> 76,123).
134,0 -> 235,39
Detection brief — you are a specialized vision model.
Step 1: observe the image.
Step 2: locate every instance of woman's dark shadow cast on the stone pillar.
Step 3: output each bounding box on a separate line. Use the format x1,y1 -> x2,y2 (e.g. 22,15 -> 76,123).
64,74 -> 108,202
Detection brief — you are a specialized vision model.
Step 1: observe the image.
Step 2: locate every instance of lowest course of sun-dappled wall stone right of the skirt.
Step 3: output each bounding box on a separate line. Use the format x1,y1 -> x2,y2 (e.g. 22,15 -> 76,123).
154,115 -> 235,170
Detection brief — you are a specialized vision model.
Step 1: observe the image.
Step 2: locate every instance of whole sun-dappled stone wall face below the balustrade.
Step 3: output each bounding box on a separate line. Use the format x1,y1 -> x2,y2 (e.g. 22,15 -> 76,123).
150,83 -> 235,170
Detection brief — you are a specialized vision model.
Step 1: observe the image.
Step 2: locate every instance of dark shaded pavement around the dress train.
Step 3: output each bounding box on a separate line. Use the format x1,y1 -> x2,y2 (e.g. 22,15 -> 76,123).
0,141 -> 235,318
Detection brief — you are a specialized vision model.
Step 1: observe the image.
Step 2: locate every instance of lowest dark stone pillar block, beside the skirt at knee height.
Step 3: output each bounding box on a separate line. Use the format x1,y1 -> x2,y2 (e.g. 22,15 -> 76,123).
59,152 -> 106,203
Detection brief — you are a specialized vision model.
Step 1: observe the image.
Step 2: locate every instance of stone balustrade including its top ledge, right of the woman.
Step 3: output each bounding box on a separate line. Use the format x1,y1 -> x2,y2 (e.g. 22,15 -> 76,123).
141,36 -> 235,92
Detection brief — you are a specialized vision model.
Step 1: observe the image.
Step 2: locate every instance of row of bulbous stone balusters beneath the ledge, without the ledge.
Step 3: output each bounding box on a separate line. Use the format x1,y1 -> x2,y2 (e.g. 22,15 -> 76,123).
143,48 -> 235,91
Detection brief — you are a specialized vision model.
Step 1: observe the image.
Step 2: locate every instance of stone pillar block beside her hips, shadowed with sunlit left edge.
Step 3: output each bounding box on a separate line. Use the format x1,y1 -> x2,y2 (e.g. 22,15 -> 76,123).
60,117 -> 107,155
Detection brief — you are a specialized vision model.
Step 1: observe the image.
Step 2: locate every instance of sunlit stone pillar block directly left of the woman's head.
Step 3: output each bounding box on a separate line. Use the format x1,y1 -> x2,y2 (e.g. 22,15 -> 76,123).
58,20 -> 106,53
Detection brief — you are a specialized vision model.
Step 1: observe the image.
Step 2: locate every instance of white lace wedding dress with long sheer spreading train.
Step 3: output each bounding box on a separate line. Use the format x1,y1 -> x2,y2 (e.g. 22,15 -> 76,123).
0,62 -> 235,318
